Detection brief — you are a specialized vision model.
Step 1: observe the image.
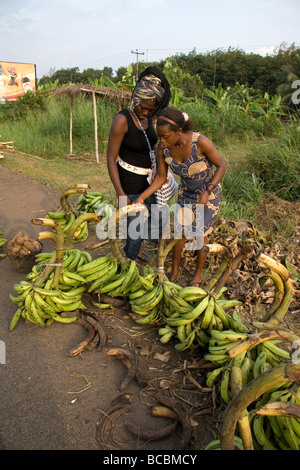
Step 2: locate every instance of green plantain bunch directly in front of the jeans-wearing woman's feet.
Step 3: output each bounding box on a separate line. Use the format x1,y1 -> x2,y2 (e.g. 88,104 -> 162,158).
128,273 -> 164,325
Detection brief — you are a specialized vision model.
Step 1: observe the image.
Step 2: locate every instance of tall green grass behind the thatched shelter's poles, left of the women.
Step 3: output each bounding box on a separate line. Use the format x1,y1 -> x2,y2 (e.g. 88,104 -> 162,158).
1,93 -> 117,158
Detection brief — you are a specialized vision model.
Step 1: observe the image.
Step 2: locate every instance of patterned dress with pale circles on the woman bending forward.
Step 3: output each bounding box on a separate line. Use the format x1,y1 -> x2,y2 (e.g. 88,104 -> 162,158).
164,132 -> 222,239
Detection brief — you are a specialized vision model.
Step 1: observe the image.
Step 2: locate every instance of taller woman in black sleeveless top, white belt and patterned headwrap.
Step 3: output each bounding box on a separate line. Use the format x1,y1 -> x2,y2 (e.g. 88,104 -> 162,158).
107,67 -> 171,259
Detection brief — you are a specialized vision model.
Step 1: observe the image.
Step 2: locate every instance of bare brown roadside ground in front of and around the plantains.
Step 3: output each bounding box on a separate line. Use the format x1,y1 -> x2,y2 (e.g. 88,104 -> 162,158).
0,168 -> 222,455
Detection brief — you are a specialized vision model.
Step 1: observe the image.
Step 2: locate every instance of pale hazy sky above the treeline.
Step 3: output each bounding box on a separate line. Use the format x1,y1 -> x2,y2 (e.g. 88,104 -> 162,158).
0,0 -> 300,78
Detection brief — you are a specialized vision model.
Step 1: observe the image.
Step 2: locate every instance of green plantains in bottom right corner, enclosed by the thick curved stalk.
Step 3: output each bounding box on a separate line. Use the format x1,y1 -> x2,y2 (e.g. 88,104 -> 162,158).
250,382 -> 300,450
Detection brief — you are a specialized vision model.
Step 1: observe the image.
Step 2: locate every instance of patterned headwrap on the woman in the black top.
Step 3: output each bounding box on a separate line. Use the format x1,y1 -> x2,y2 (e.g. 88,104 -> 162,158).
130,74 -> 165,108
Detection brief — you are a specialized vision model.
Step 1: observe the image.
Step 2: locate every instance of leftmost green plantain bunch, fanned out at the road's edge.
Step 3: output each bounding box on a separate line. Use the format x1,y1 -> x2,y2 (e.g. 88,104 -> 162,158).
9,278 -> 85,331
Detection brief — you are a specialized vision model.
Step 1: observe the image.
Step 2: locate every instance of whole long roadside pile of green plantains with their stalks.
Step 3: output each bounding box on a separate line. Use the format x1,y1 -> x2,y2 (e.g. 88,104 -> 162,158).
10,185 -> 300,450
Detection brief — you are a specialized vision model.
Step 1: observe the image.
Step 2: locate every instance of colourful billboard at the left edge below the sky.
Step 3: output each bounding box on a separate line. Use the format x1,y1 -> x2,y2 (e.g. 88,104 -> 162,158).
0,61 -> 36,104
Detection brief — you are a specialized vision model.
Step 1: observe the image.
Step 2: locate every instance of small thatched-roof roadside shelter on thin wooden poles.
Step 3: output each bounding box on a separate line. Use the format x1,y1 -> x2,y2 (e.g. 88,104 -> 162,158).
47,83 -> 132,163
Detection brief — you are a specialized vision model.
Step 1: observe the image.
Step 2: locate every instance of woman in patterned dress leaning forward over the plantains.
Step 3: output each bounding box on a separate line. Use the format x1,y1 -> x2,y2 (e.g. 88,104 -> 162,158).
156,108 -> 226,286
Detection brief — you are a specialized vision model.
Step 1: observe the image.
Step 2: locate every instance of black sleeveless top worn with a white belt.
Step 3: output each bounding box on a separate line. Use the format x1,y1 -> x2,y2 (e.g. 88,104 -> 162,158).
118,109 -> 158,194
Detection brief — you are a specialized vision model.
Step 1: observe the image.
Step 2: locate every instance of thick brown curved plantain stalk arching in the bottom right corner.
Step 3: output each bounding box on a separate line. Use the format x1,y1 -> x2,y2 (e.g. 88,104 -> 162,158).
220,363 -> 300,450
